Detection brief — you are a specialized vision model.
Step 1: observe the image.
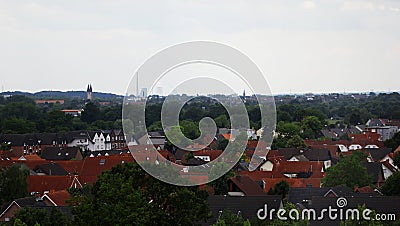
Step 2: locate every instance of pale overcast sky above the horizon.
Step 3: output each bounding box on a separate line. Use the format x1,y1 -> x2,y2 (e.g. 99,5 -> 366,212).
0,0 -> 400,94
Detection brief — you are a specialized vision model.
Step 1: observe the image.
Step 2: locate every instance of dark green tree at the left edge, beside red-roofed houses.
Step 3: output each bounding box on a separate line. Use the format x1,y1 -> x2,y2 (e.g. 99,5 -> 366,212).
0,164 -> 29,205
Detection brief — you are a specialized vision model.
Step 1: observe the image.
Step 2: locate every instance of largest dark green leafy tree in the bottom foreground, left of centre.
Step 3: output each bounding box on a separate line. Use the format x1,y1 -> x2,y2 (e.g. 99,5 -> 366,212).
71,163 -> 209,225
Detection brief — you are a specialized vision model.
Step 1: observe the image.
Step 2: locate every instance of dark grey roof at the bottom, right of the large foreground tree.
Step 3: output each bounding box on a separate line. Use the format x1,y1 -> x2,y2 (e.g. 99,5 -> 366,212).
206,195 -> 283,225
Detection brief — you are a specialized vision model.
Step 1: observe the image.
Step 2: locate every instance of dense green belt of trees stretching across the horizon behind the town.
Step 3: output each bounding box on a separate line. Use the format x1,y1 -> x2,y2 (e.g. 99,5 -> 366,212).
0,93 -> 400,137
